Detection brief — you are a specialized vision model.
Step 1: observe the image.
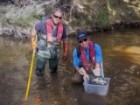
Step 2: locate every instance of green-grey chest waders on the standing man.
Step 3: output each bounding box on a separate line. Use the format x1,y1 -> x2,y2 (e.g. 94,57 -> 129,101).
36,34 -> 60,75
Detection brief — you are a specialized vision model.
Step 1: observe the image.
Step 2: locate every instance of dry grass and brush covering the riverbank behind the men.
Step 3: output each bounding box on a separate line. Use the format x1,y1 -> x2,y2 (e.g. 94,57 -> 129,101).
0,0 -> 140,37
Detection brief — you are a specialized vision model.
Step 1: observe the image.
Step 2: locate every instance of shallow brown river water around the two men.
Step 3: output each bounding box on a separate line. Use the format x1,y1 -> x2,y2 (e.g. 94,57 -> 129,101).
0,29 -> 140,105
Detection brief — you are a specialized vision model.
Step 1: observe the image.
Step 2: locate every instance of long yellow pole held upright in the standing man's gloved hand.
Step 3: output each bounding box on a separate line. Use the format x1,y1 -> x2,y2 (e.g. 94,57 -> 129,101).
24,35 -> 37,101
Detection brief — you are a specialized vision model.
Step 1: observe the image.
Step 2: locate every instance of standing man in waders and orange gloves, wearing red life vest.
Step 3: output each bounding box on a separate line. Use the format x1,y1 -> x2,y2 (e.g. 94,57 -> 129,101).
31,8 -> 69,76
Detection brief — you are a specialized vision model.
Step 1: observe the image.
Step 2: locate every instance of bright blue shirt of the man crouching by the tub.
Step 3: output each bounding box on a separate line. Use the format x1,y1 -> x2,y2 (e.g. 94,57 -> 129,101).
73,43 -> 103,69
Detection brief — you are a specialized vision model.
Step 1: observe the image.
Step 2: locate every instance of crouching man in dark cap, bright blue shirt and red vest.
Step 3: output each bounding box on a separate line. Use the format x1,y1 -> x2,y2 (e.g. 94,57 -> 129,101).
72,32 -> 103,83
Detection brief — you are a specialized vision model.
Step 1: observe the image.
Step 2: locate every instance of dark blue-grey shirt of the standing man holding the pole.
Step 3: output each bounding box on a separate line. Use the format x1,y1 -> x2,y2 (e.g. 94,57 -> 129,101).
35,17 -> 68,40
